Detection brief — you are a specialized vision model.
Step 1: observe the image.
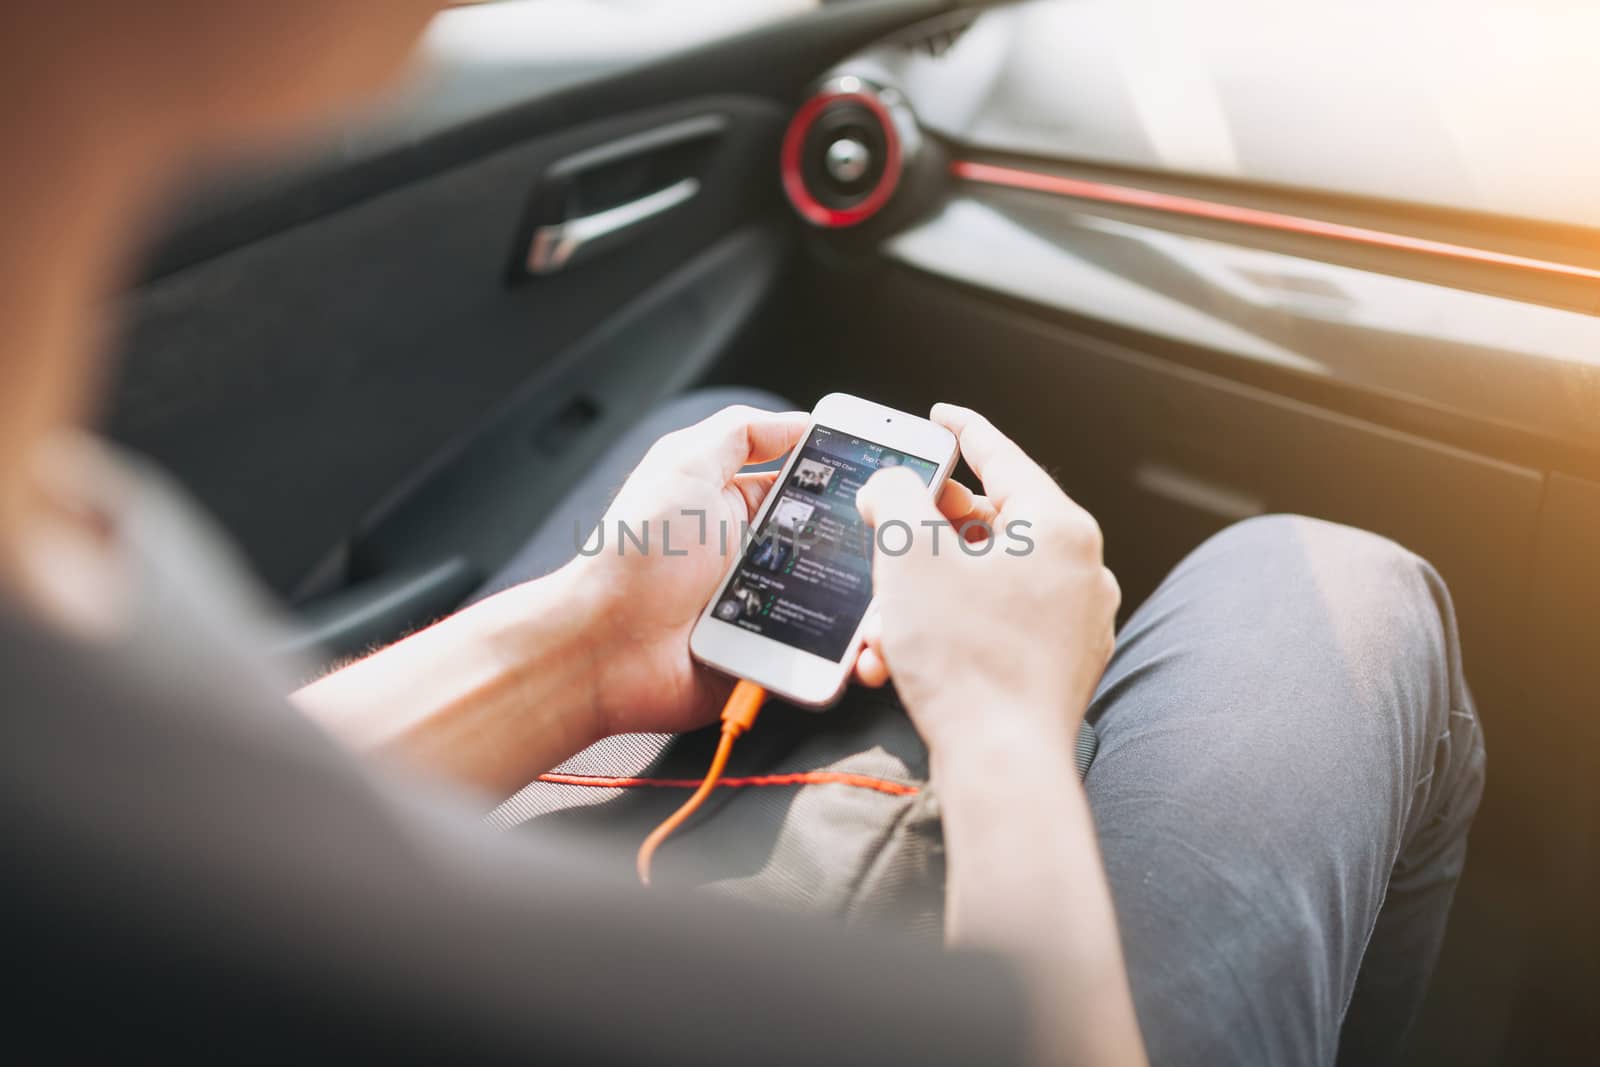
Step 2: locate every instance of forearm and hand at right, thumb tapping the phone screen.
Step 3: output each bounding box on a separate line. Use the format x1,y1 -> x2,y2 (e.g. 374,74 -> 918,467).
859,405 -> 1146,1064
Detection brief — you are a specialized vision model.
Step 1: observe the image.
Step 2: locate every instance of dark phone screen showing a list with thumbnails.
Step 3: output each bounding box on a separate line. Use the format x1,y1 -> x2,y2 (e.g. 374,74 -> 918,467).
712,426 -> 939,661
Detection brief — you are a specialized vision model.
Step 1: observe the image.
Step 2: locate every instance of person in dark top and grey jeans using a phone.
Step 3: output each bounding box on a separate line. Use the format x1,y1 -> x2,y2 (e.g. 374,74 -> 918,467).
0,0 -> 1482,1062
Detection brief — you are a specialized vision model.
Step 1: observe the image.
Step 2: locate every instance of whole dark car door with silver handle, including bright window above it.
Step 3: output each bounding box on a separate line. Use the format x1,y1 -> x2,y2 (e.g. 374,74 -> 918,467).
107,0 -> 944,653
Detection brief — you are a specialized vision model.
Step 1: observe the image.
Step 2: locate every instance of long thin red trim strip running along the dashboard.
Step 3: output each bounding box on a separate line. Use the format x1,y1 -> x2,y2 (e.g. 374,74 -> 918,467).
950,160 -> 1600,282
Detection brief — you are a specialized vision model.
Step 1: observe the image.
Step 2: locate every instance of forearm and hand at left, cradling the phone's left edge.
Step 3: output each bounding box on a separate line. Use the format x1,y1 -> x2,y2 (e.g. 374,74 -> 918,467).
294,406 -> 806,797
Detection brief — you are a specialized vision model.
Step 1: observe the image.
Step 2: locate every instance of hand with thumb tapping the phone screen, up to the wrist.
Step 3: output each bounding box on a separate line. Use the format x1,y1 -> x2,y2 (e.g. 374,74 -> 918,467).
858,405 -> 1122,755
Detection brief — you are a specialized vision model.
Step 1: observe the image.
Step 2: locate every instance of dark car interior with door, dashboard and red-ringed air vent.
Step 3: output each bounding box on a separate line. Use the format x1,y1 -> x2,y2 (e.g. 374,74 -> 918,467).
106,0 -> 1600,1064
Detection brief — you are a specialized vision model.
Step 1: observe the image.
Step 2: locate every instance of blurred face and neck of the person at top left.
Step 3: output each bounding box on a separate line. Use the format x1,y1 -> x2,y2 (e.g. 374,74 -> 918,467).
0,0 -> 442,581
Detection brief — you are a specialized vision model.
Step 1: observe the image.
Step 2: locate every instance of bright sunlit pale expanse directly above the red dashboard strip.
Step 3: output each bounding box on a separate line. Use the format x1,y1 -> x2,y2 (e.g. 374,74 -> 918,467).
899,0 -> 1600,226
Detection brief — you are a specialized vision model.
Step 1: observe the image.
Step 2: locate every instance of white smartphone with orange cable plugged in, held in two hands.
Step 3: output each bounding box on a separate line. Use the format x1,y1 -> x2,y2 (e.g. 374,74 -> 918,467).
690,394 -> 957,709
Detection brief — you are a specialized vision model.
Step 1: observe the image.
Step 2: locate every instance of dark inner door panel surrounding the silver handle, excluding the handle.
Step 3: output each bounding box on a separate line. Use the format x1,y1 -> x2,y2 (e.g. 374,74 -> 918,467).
112,98 -> 781,590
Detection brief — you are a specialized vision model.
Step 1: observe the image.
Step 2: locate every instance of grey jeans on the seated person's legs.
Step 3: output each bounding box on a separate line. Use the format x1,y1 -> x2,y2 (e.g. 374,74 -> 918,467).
485,390 -> 1483,1064
